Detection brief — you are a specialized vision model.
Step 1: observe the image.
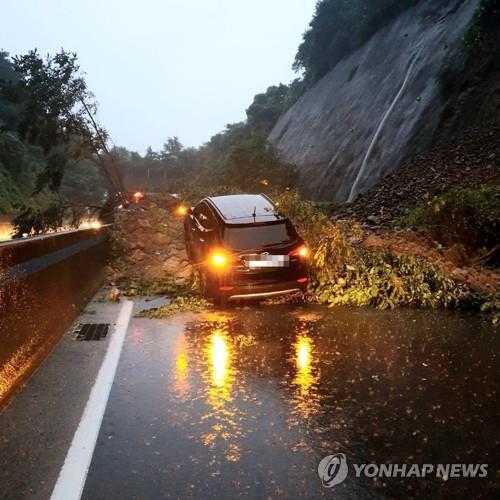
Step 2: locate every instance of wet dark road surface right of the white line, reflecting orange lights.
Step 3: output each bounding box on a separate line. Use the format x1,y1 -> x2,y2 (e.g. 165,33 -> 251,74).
84,306 -> 500,499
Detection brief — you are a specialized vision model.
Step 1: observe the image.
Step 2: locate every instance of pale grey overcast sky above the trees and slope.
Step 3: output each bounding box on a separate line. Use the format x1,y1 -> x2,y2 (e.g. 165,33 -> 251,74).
0,0 -> 316,153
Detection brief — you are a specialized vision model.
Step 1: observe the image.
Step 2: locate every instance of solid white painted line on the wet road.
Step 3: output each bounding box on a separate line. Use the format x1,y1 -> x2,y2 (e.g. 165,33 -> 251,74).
50,300 -> 134,500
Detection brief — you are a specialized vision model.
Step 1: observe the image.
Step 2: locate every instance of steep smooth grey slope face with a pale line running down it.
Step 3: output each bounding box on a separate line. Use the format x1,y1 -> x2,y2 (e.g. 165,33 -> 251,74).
269,0 -> 479,202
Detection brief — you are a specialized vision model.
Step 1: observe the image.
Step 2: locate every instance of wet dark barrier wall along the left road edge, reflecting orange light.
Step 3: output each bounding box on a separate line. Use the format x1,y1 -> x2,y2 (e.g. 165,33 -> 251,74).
0,226 -> 110,409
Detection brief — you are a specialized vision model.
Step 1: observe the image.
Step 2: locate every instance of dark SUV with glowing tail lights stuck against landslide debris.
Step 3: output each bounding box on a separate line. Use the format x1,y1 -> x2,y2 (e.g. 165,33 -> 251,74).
184,194 -> 308,303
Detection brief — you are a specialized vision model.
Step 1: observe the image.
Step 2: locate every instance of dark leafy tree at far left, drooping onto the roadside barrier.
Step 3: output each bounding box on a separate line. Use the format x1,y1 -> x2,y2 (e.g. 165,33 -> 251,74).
0,50 -> 114,236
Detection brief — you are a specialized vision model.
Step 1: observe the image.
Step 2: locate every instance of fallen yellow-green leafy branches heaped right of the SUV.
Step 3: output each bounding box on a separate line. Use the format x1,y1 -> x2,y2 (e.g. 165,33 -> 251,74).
277,191 -> 475,309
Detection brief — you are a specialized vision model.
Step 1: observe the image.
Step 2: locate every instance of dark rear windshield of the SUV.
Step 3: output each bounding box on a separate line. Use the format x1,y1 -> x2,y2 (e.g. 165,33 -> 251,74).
223,221 -> 297,250
